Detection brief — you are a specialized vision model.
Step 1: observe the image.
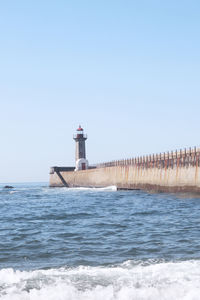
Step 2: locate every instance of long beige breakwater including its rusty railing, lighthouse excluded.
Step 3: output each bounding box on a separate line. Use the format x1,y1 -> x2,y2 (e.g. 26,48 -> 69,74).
50,147 -> 200,193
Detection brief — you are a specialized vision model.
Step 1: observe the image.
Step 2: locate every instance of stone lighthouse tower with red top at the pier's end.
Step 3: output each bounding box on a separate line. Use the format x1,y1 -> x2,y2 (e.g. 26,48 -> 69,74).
73,125 -> 88,171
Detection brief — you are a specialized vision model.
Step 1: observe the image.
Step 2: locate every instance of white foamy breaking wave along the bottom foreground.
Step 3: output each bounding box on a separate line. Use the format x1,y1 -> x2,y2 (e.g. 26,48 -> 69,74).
0,260 -> 200,300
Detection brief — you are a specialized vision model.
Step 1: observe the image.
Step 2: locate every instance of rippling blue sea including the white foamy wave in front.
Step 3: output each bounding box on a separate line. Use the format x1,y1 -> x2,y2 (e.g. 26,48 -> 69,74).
0,183 -> 200,300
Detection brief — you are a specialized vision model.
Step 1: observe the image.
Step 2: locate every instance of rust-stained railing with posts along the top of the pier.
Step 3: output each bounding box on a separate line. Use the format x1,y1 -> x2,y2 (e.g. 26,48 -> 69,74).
96,147 -> 200,168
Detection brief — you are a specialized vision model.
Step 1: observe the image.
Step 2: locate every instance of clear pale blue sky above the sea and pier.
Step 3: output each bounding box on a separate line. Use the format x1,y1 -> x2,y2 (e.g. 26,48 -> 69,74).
0,0 -> 200,182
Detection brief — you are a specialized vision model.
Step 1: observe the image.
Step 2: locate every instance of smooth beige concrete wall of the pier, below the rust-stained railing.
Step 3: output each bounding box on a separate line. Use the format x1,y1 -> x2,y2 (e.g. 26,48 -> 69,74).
50,166 -> 200,192
